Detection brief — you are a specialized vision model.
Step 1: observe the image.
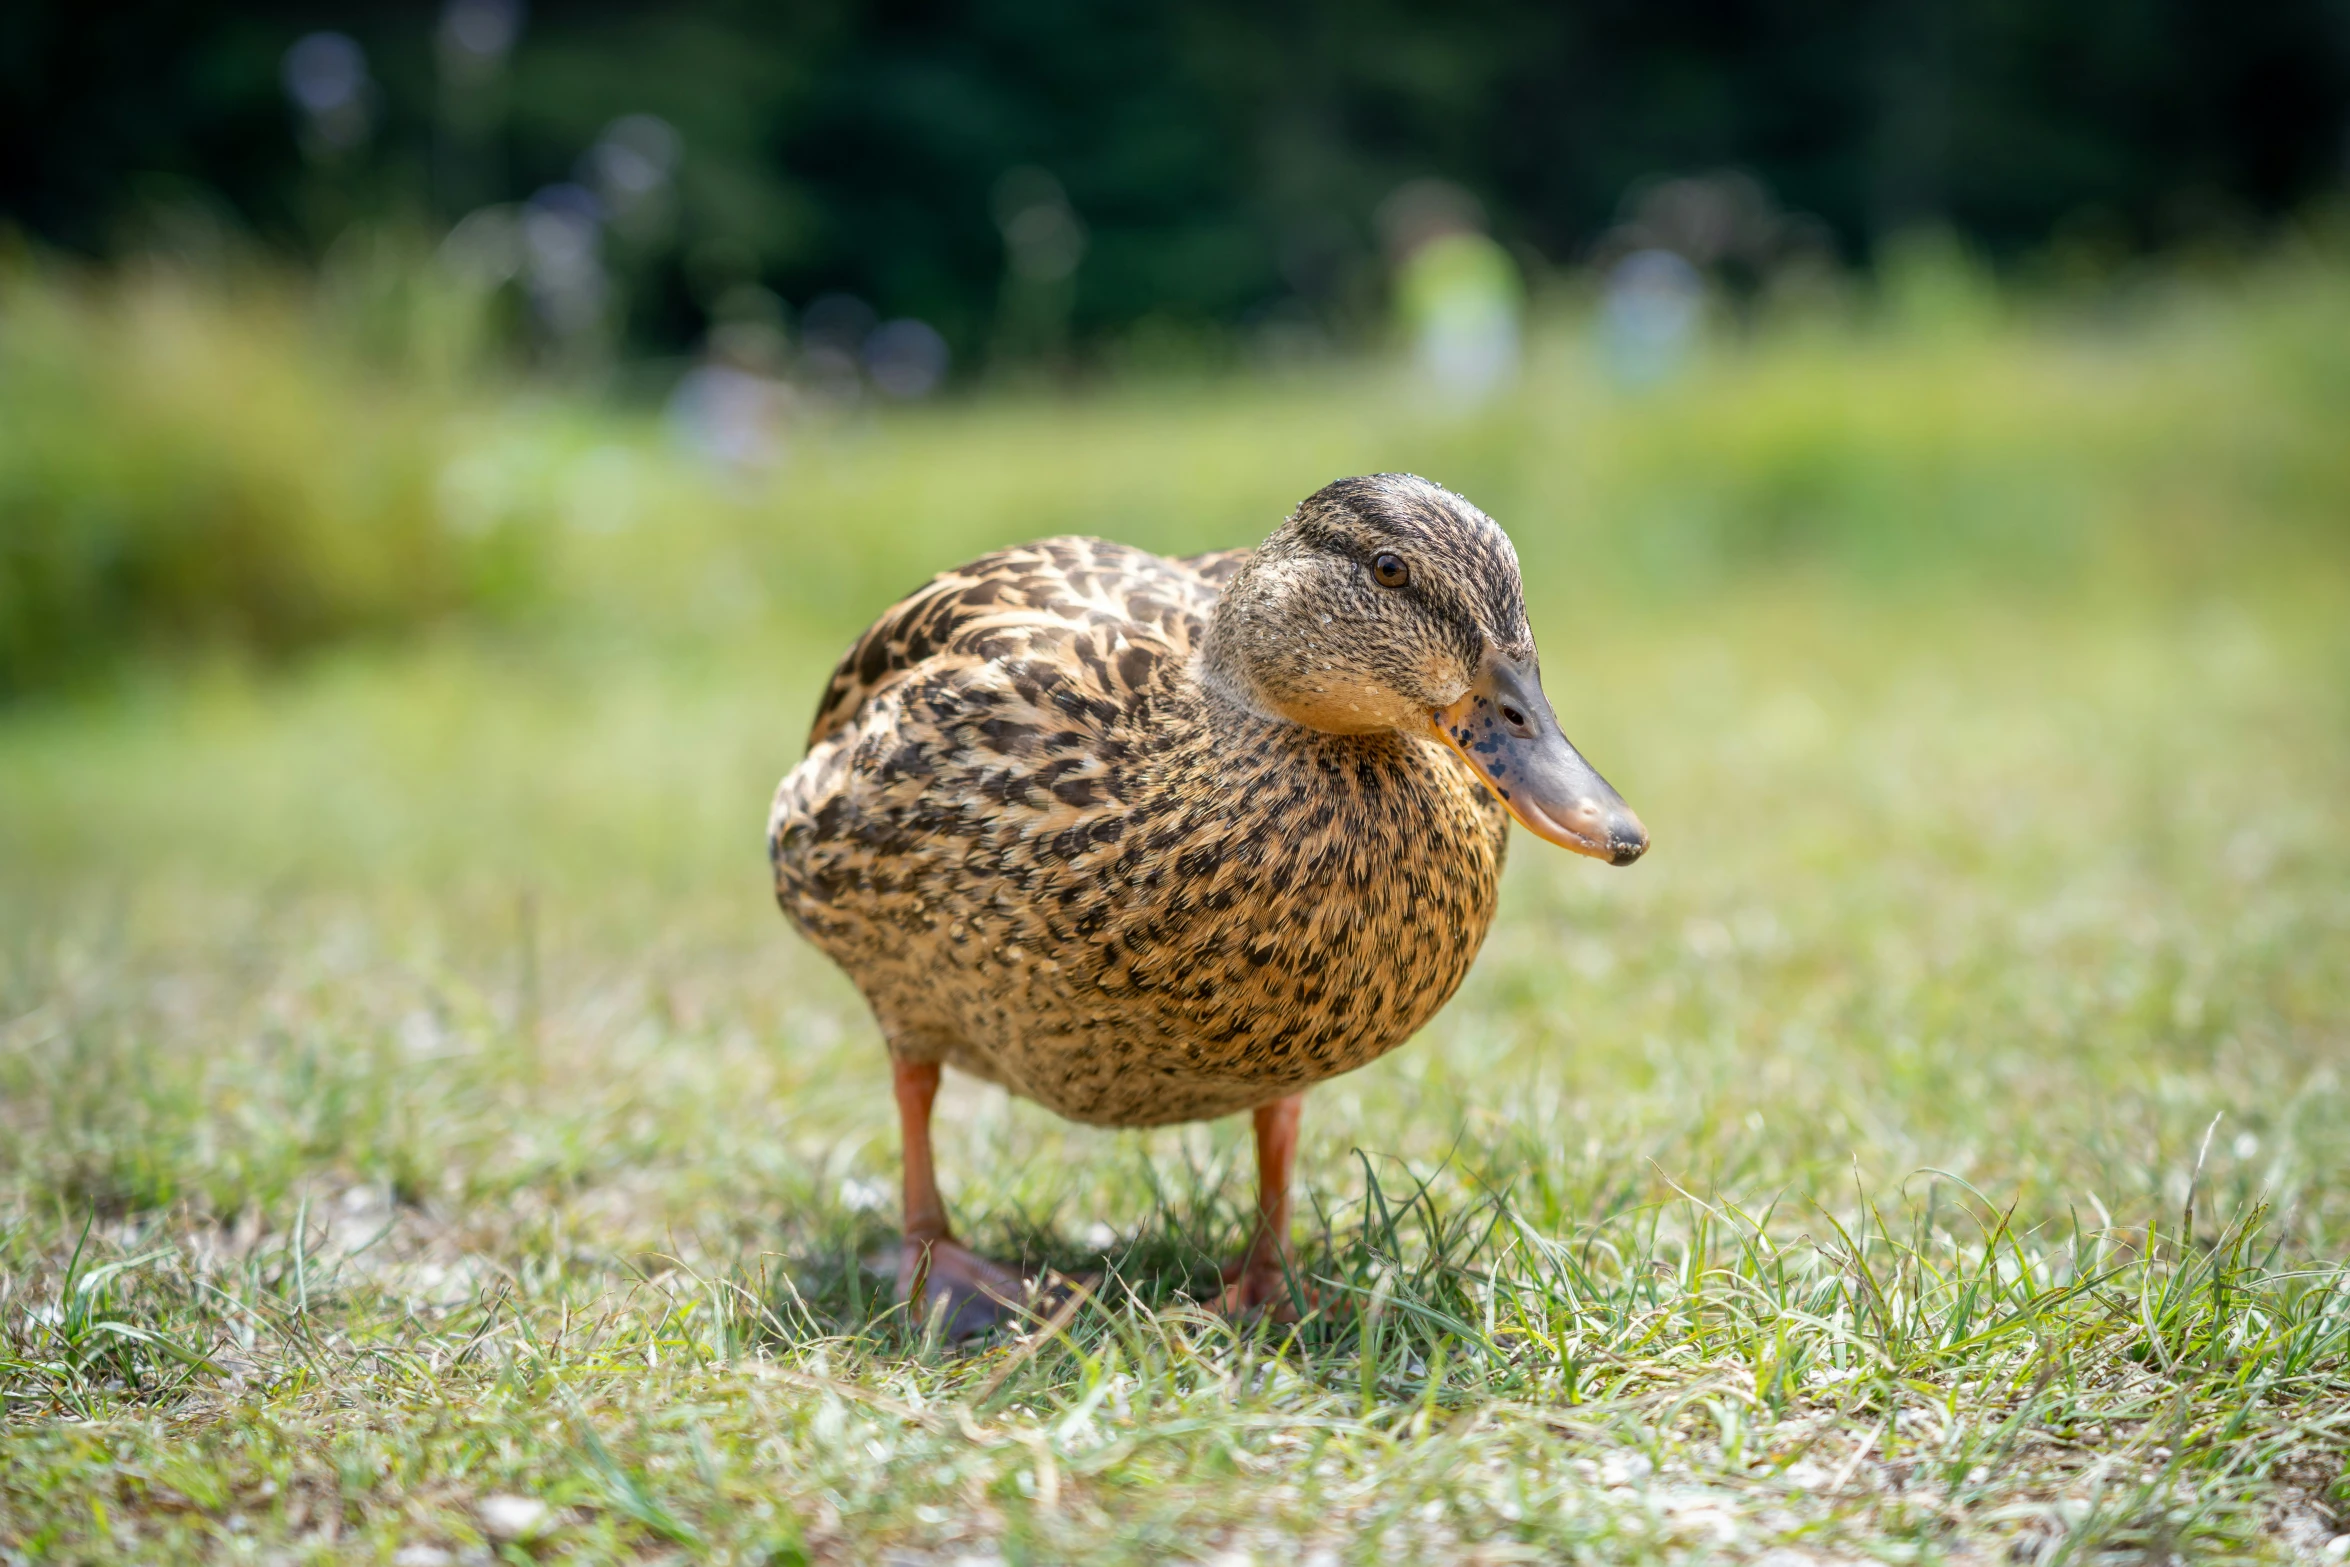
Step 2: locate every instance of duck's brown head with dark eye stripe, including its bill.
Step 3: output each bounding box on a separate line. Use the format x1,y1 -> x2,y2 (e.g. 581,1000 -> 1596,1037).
1201,475 -> 1647,865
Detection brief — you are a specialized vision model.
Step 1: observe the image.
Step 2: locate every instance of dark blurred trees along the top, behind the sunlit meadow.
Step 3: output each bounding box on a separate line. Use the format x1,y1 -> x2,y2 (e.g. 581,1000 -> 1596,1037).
0,0 -> 2350,371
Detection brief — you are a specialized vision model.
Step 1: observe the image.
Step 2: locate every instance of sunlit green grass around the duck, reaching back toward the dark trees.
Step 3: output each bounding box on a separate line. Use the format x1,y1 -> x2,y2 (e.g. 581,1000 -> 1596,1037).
0,251 -> 2350,1567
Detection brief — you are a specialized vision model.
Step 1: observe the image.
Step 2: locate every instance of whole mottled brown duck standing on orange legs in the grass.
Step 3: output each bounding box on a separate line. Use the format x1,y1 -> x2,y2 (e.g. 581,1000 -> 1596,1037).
768,475 -> 1647,1332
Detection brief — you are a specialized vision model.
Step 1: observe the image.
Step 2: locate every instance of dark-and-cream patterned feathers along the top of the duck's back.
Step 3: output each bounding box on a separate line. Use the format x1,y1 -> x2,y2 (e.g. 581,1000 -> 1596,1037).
808,538 -> 1255,747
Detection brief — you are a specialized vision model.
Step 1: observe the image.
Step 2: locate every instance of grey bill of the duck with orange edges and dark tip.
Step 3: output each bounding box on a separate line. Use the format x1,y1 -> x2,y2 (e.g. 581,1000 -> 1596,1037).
1429,660 -> 1647,865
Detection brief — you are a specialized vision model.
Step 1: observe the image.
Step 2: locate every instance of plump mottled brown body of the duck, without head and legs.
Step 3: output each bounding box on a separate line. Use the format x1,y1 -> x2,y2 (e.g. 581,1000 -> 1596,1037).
768,538 -> 1506,1125
